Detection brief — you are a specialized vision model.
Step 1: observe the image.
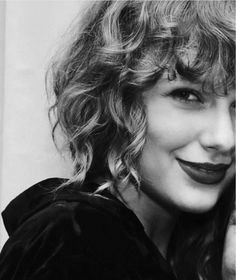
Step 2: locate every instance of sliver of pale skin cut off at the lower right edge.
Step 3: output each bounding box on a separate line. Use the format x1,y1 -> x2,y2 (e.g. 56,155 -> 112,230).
222,210 -> 236,280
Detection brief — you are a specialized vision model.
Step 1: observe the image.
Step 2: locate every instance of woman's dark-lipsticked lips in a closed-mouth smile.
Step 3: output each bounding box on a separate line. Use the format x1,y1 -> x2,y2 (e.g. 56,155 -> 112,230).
177,158 -> 230,184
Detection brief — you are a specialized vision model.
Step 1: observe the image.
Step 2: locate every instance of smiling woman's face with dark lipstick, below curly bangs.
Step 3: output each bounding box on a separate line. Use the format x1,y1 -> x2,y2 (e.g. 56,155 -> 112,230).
140,70 -> 235,213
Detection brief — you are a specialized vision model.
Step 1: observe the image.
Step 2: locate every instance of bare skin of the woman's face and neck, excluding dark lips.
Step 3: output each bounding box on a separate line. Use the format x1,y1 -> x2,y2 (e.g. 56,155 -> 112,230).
122,73 -> 235,262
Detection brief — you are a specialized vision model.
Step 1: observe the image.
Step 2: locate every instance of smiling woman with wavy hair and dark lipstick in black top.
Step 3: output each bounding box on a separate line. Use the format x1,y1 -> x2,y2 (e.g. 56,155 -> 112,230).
0,0 -> 235,280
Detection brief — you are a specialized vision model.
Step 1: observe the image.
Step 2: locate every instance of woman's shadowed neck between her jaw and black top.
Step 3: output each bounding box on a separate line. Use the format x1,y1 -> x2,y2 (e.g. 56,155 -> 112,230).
116,187 -> 176,258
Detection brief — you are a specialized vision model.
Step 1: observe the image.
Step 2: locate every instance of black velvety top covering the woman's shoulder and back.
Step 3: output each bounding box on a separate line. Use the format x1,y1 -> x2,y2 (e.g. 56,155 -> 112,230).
0,178 -> 176,280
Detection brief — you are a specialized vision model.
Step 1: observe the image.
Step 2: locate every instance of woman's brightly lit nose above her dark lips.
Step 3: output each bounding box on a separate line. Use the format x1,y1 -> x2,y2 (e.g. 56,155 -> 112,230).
200,108 -> 235,155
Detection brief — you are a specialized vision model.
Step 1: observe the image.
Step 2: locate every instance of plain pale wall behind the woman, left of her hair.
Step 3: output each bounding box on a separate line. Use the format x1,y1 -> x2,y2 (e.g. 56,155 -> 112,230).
0,0 -> 88,248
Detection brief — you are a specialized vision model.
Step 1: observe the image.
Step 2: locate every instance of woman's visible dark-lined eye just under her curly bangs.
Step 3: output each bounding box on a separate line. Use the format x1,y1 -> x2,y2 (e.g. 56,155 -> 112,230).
168,88 -> 204,104
